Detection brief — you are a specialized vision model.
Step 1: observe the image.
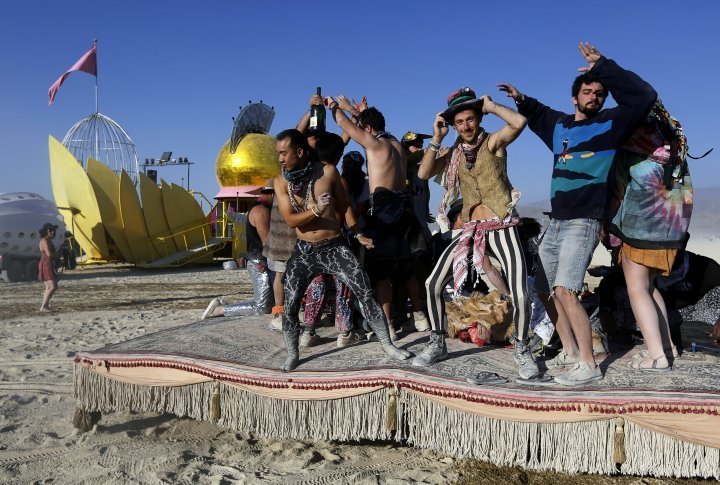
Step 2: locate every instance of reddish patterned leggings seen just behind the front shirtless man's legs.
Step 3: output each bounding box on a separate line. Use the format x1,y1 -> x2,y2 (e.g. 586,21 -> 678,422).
305,275 -> 352,332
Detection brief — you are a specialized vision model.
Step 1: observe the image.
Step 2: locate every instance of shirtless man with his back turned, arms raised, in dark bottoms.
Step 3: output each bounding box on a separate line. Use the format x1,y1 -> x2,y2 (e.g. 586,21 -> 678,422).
325,96 -> 427,337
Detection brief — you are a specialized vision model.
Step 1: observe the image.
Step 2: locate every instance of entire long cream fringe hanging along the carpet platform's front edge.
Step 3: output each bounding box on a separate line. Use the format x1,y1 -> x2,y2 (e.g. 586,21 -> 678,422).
74,365 -> 720,479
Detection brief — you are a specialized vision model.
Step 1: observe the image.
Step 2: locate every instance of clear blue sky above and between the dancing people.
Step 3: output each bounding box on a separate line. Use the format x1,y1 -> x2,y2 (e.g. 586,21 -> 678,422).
0,0 -> 720,212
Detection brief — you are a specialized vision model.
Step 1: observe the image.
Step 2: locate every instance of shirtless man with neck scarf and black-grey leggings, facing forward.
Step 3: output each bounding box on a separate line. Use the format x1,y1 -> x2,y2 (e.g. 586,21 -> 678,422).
275,130 -> 411,372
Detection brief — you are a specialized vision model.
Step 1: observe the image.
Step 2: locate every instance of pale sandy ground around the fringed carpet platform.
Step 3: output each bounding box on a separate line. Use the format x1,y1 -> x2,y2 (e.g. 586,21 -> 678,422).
0,260 -> 716,484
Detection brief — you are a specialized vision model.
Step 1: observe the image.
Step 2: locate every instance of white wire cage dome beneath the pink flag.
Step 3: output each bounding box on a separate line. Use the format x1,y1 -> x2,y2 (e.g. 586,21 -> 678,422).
62,112 -> 138,181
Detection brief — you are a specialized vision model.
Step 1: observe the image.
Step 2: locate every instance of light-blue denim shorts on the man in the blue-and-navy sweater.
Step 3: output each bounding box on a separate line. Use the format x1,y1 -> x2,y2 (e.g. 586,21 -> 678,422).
535,219 -> 601,294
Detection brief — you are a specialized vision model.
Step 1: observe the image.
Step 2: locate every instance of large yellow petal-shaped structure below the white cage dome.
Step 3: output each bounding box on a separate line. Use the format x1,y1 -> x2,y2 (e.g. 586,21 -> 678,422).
48,136 -> 221,267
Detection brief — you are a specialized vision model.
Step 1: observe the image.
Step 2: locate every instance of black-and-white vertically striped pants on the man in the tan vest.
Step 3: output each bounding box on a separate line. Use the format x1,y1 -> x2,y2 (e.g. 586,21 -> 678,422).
425,226 -> 530,340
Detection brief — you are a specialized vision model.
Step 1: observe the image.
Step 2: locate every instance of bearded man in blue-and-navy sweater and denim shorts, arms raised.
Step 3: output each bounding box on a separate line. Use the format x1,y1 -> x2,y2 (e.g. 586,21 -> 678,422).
499,44 -> 657,386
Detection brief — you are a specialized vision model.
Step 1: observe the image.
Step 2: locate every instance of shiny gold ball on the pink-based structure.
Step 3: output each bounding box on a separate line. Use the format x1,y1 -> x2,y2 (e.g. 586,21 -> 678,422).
215,133 -> 280,187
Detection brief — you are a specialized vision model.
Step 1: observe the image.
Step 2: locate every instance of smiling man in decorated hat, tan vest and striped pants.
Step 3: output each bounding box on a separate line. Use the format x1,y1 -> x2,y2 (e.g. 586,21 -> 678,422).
413,87 -> 538,379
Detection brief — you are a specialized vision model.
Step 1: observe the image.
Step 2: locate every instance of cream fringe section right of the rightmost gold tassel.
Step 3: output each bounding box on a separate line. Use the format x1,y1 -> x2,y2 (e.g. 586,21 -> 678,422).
622,421 -> 720,480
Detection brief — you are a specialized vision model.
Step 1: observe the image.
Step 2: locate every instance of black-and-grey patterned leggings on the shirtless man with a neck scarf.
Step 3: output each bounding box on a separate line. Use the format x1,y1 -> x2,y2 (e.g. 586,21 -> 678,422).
283,236 -> 385,331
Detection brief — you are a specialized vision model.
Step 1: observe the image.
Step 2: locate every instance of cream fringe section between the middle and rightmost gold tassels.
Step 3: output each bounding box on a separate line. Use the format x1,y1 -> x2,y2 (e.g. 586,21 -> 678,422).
402,391 -> 617,474
